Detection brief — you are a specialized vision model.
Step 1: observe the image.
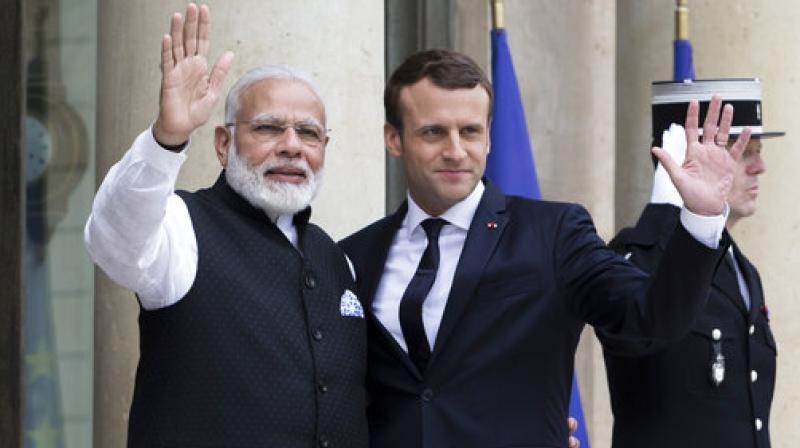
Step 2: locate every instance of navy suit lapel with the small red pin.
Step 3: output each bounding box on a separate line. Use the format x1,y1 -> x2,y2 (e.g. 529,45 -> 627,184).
428,182 -> 508,369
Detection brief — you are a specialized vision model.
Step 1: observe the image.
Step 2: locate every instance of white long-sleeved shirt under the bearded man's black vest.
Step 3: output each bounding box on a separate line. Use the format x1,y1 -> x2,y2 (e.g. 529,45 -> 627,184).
84,129 -> 297,310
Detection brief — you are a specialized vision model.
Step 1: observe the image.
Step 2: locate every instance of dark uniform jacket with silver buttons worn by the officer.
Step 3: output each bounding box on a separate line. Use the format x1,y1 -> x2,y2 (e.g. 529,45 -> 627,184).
598,204 -> 776,448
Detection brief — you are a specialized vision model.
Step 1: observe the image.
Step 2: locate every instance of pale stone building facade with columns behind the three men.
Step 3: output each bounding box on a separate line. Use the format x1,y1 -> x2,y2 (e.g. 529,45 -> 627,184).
0,0 -> 800,448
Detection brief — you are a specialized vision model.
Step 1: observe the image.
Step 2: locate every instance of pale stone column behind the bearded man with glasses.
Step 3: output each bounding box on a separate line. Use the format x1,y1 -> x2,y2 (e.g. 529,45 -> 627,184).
94,0 -> 385,447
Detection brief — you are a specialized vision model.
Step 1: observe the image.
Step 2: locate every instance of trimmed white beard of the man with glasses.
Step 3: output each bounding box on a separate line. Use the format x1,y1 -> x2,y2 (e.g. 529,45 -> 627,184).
225,142 -> 323,219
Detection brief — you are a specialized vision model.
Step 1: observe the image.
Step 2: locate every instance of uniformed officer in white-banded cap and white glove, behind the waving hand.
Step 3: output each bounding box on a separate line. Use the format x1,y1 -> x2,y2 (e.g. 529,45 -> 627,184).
598,79 -> 783,448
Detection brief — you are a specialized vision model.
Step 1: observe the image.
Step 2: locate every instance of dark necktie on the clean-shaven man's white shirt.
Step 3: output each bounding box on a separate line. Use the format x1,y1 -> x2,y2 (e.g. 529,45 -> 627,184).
400,218 -> 447,372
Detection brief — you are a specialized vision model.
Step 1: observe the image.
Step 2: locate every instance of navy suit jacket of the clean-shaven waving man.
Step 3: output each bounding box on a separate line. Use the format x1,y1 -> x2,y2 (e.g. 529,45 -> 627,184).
341,183 -> 725,448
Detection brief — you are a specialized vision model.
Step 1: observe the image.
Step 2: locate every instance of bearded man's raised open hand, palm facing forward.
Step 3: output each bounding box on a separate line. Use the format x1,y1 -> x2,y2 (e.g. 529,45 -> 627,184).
153,3 -> 233,145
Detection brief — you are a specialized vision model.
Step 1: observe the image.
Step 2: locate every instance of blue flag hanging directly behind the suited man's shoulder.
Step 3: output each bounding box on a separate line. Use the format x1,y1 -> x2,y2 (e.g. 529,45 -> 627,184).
486,29 -> 589,448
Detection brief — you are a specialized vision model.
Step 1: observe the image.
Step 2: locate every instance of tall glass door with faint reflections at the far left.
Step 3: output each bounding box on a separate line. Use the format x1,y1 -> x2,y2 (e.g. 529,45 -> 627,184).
20,0 -> 97,448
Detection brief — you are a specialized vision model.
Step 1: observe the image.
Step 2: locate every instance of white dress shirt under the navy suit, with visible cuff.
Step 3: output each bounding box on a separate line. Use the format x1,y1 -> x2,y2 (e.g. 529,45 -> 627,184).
372,182 -> 728,352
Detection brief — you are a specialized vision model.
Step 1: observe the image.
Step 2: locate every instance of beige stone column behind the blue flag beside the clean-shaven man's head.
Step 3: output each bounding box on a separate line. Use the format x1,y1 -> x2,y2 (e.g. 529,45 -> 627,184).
456,0 -> 616,447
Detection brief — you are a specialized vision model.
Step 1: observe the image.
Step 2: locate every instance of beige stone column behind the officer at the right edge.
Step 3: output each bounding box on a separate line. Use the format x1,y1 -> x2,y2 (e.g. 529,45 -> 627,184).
617,0 -> 800,446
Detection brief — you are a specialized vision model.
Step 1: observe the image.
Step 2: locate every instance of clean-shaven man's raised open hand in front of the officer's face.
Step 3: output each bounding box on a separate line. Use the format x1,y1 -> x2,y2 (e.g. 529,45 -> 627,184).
653,95 -> 750,216
